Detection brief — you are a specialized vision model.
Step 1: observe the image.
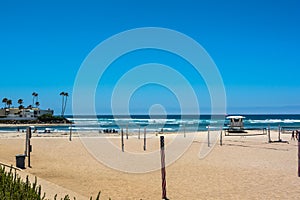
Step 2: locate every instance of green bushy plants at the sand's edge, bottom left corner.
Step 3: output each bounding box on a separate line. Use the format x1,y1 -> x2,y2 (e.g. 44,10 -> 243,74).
0,166 -> 100,200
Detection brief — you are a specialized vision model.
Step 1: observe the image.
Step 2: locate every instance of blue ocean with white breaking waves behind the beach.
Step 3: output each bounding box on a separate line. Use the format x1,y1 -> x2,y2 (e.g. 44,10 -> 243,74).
0,114 -> 300,133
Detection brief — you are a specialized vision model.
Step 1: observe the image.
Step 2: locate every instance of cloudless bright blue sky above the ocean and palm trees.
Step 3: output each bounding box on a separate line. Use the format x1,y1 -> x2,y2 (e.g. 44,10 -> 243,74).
0,0 -> 300,114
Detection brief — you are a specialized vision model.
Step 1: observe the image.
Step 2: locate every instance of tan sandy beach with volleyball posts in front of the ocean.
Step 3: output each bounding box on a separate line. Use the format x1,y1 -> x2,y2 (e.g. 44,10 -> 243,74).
0,131 -> 300,199
